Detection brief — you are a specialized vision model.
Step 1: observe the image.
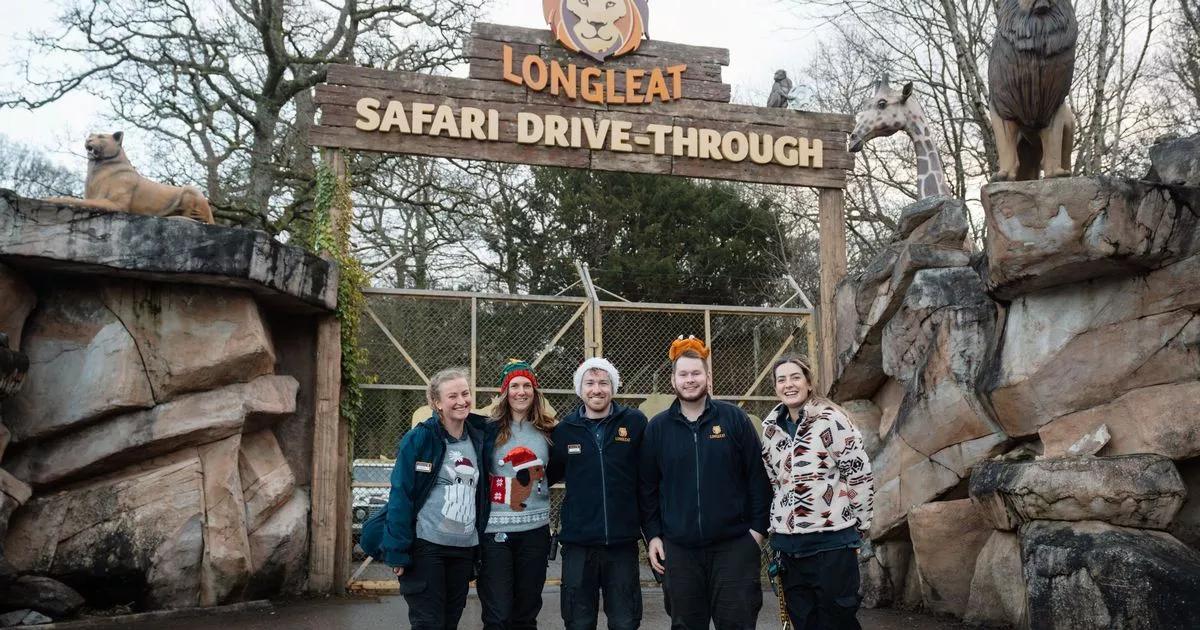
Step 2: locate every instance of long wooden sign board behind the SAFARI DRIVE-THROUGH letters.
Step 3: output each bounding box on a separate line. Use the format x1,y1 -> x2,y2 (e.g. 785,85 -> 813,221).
310,65 -> 854,188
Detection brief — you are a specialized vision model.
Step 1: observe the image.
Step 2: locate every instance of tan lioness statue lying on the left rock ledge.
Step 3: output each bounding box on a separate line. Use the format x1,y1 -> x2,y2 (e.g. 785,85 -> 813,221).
47,131 -> 214,223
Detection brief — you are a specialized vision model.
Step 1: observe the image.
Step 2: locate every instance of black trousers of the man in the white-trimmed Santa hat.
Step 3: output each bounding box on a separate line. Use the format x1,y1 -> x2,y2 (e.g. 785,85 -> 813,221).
560,542 -> 642,630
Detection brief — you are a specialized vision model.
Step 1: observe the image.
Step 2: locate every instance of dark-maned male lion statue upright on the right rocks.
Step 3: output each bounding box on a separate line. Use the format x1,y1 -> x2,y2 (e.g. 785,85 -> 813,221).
988,0 -> 1079,181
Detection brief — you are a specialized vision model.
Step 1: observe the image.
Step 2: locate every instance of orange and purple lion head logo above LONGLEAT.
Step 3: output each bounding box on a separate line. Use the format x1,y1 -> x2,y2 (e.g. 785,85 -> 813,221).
541,0 -> 649,61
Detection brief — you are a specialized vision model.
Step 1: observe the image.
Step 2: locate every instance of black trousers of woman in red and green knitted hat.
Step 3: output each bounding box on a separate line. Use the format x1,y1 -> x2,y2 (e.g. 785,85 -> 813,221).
475,526 -> 550,630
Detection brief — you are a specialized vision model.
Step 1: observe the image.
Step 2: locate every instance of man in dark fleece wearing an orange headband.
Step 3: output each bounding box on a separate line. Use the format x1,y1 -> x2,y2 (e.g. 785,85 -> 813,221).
638,337 -> 770,630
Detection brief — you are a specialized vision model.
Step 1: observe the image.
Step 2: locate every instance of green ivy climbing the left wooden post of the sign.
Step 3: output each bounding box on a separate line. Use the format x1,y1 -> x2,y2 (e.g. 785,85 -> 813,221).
307,163 -> 368,433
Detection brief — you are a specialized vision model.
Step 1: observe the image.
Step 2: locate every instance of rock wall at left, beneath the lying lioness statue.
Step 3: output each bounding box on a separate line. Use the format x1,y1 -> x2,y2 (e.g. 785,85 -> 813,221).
0,191 -> 336,618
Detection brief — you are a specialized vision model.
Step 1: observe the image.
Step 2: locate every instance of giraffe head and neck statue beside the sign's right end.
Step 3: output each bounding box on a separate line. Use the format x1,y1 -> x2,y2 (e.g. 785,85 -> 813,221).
850,74 -> 950,199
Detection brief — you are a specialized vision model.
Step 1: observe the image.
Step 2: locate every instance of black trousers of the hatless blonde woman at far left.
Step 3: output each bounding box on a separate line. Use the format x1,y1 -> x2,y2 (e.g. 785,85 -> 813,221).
400,539 -> 475,630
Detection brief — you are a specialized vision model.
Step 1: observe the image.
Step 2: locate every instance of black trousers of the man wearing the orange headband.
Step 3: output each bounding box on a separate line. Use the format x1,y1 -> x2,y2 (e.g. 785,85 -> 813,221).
664,532 -> 762,630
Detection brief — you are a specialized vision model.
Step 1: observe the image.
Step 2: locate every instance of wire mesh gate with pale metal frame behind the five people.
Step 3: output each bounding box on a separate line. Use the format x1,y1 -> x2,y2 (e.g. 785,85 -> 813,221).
350,284 -> 815,564
